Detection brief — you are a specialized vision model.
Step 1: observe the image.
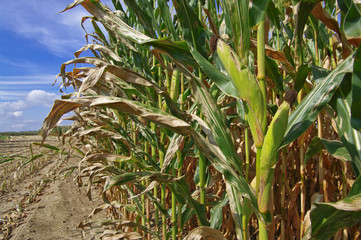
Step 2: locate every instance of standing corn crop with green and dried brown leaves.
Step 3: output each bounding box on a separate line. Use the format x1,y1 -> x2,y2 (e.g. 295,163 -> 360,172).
42,0 -> 361,240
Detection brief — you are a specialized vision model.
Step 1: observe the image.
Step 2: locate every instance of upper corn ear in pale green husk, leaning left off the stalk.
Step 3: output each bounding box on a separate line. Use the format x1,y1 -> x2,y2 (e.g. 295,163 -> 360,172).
216,39 -> 267,147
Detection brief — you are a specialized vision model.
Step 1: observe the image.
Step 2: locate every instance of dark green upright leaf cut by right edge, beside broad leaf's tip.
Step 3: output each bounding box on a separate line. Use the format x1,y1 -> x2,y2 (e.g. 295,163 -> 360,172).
351,47 -> 361,132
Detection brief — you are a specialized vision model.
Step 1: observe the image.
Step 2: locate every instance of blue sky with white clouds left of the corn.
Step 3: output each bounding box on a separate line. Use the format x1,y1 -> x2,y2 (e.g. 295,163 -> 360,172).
0,0 -> 109,132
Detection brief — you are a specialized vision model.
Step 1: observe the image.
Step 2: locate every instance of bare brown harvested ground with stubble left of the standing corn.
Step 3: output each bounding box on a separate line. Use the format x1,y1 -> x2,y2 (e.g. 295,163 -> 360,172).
0,136 -> 103,240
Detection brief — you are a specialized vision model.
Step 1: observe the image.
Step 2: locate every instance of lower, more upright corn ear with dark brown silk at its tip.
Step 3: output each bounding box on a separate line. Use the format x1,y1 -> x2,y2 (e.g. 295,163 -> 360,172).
258,91 -> 297,213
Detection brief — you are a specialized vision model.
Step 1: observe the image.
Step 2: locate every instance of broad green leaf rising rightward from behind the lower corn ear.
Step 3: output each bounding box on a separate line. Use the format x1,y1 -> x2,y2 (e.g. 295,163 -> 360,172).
283,53 -> 353,146
